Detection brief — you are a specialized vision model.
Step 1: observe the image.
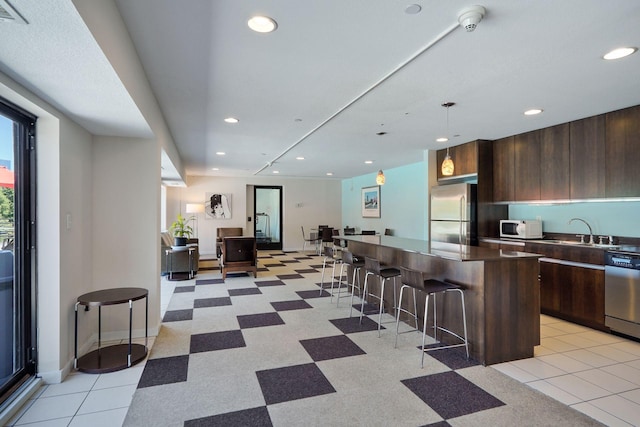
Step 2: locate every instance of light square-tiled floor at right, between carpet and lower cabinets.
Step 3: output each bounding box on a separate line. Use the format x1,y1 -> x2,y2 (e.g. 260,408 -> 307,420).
493,315 -> 640,426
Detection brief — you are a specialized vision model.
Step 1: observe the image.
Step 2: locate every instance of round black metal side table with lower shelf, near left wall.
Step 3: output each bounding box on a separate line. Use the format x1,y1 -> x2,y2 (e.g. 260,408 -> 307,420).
74,288 -> 149,374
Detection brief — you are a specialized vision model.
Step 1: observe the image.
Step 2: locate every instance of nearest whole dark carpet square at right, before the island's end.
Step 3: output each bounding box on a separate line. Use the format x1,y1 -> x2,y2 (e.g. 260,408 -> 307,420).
402,371 -> 504,419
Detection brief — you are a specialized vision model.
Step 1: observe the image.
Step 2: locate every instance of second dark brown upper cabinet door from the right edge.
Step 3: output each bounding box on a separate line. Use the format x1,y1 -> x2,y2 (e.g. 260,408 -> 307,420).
569,114 -> 605,200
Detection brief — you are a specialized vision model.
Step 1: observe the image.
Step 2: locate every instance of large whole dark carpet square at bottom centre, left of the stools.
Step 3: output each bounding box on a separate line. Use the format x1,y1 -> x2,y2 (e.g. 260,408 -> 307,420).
256,363 -> 336,404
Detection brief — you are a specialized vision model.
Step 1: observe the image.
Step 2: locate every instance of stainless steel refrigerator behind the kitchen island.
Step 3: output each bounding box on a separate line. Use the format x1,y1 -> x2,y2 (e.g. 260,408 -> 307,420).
429,183 -> 478,246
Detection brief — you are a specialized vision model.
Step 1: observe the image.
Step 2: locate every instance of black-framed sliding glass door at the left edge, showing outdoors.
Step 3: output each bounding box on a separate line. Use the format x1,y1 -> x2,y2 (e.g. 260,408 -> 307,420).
0,99 -> 36,408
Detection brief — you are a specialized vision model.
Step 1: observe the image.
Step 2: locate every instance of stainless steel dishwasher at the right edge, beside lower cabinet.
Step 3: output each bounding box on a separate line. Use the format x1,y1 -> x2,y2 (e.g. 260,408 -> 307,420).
604,250 -> 640,338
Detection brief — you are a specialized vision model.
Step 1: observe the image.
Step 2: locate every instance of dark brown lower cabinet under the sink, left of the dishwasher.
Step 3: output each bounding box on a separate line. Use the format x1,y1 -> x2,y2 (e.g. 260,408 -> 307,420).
540,260 -> 607,330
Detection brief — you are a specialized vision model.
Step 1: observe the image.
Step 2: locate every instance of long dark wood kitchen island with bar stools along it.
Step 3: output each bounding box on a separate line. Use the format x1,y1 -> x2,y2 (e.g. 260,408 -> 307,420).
341,236 -> 542,365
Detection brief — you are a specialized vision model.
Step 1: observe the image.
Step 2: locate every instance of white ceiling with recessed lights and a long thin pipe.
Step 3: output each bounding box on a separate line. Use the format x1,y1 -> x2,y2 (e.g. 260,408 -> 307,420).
0,0 -> 640,178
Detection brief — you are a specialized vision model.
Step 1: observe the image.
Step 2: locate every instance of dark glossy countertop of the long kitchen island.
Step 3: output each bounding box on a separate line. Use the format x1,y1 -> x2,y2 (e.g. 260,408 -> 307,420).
340,235 -> 543,261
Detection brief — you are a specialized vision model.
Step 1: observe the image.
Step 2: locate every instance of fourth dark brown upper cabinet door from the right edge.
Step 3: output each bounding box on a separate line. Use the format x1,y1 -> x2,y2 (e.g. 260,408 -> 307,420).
513,131 -> 541,201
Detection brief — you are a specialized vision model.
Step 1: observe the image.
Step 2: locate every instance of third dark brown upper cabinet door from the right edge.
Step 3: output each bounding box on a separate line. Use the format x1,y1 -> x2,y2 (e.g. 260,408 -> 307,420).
539,123 -> 570,200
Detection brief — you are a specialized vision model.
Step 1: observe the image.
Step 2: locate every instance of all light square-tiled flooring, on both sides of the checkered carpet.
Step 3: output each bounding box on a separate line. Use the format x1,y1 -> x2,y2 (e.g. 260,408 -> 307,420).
8,272 -> 640,427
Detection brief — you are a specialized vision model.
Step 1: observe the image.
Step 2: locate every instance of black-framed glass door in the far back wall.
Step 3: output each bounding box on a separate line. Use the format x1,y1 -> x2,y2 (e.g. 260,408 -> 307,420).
253,185 -> 282,250
